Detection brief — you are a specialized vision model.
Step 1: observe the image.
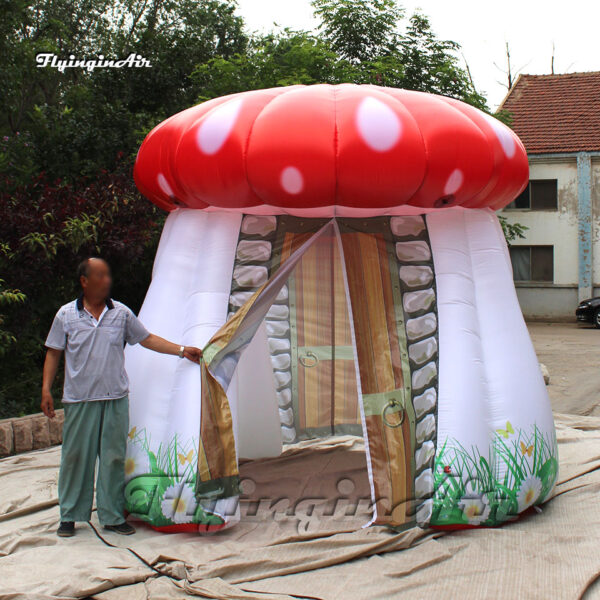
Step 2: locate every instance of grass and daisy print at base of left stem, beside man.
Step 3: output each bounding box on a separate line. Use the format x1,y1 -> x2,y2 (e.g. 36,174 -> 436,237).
125,427 -> 226,532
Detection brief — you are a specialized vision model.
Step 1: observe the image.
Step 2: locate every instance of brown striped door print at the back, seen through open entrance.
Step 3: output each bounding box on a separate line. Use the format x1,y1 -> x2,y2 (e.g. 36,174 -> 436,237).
276,217 -> 362,439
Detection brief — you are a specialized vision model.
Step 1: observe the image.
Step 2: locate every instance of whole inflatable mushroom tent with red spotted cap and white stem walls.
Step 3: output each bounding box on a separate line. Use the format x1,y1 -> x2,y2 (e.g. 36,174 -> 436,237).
126,84 -> 558,531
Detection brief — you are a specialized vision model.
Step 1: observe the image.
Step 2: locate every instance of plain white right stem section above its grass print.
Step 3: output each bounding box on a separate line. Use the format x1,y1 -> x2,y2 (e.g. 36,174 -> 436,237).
427,208 -> 554,477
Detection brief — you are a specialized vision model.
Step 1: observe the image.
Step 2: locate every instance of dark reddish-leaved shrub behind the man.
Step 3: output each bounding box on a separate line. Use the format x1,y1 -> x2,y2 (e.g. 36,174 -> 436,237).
0,157 -> 164,417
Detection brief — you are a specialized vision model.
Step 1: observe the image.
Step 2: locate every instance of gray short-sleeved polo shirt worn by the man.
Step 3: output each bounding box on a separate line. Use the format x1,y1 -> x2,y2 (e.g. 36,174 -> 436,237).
46,297 -> 150,402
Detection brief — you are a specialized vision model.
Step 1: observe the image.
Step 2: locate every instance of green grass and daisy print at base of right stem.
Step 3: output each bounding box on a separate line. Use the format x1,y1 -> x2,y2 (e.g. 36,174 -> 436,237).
431,423 -> 558,526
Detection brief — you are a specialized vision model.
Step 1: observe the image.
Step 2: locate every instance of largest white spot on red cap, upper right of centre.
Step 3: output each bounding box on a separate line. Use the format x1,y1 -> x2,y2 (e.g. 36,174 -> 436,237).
356,96 -> 402,152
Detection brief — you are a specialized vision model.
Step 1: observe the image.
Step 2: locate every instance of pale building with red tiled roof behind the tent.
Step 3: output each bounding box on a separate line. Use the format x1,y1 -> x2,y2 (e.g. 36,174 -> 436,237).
500,72 -> 600,318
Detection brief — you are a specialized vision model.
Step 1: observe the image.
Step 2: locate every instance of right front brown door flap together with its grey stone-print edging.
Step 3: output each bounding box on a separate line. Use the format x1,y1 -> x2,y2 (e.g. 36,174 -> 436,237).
338,215 -> 438,528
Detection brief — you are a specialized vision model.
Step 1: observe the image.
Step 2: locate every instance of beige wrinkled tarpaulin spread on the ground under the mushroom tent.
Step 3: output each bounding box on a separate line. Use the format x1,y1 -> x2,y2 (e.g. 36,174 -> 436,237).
0,414 -> 600,600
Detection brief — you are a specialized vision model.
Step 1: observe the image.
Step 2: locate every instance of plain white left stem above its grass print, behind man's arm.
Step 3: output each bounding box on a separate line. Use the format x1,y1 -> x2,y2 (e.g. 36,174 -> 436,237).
126,209 -> 241,468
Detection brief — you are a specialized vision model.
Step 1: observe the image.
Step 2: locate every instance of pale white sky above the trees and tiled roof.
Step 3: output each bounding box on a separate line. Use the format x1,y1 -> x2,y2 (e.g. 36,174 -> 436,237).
238,0 -> 600,108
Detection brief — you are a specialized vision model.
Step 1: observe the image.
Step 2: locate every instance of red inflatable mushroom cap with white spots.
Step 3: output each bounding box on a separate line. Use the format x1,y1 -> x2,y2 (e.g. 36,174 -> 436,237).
134,84 -> 529,215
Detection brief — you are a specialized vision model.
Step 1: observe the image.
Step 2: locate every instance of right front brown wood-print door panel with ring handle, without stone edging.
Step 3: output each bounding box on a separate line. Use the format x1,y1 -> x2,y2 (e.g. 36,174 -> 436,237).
340,220 -> 415,525
